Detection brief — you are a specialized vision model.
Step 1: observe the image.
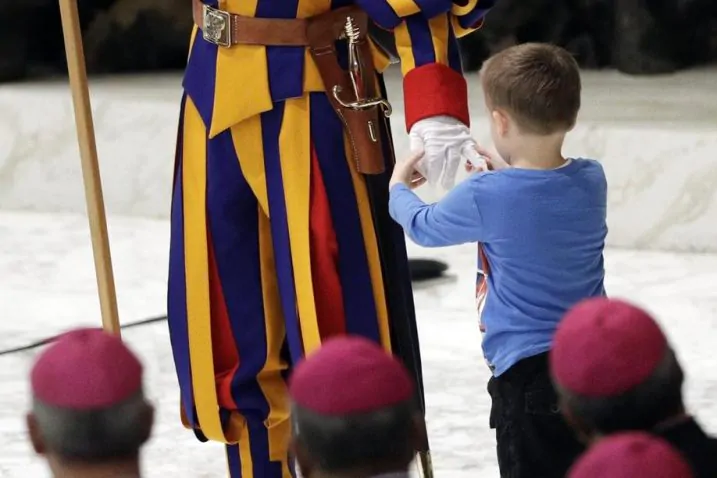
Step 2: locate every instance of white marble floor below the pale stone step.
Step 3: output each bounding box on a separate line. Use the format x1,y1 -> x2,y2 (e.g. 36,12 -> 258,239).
0,212 -> 717,478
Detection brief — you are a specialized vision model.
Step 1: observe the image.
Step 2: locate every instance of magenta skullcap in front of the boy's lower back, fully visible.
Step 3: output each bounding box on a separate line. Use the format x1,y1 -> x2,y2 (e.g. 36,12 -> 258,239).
550,297 -> 668,398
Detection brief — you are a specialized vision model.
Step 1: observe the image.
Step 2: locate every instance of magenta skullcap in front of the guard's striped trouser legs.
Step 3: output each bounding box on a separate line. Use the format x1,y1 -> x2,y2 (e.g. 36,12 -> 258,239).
289,337 -> 414,416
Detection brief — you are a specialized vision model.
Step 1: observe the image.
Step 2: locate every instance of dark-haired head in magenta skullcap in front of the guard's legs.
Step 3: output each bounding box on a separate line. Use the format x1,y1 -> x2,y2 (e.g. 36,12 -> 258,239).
289,337 -> 425,478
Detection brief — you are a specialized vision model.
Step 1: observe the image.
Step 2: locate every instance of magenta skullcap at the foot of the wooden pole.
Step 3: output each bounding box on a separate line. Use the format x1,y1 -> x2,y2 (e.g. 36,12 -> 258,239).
30,329 -> 142,410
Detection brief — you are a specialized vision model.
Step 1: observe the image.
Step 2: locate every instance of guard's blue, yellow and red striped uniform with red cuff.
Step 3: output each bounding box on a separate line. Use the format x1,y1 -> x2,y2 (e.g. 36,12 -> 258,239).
168,0 -> 489,478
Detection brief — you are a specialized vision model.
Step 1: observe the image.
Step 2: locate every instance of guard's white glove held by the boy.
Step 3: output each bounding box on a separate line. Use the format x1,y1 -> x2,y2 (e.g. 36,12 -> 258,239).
409,116 -> 486,190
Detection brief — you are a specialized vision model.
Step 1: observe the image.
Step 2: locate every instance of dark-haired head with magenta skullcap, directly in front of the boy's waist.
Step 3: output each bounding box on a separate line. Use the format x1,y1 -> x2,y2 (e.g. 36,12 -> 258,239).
550,298 -> 684,440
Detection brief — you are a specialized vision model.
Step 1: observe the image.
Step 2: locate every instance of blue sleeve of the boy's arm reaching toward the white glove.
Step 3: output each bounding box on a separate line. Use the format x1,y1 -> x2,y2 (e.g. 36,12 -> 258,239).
388,180 -> 484,247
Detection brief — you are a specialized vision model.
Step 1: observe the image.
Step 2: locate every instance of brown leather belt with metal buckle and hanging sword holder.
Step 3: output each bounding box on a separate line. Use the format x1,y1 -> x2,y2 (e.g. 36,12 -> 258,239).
192,0 -> 391,174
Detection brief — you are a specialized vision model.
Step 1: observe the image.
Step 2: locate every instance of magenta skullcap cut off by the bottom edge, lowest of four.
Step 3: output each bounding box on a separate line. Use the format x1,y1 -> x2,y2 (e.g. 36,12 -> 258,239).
568,432 -> 694,478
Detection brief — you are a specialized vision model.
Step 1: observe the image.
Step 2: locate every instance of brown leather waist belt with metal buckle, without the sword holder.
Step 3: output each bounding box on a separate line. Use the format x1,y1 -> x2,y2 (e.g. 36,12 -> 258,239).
192,0 -> 309,47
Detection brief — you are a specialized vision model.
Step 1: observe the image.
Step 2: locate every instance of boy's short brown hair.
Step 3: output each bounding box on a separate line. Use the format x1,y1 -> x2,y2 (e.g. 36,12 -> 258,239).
481,43 -> 581,135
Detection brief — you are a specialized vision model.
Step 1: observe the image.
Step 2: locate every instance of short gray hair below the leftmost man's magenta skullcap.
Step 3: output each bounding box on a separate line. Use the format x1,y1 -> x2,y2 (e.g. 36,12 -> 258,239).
32,391 -> 152,462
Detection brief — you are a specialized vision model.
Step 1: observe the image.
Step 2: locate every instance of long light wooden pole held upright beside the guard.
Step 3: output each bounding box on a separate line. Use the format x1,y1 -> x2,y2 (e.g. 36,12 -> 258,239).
60,0 -> 120,335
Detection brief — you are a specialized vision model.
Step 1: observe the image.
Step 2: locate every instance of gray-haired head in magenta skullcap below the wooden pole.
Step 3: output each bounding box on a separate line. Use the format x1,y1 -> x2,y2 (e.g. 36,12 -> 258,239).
27,329 -> 154,478
